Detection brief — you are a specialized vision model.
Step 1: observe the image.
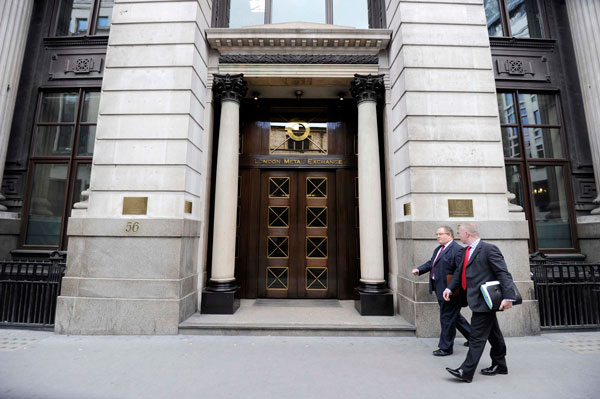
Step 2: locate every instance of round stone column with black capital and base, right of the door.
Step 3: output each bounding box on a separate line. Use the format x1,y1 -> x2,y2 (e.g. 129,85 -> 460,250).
350,74 -> 394,316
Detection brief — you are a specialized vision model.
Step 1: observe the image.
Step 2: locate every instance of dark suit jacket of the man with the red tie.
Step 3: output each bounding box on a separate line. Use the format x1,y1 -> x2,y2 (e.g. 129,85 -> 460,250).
448,241 -> 515,312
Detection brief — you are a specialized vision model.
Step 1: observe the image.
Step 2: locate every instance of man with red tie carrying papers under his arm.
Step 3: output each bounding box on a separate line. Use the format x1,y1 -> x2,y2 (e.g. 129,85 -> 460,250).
444,223 -> 515,382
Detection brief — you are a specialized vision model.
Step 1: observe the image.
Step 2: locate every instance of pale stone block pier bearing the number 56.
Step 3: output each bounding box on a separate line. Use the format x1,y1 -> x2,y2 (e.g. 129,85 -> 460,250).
56,0 -> 212,334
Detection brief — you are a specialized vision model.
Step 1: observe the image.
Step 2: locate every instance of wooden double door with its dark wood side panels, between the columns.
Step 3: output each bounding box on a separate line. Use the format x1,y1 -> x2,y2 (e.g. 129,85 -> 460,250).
236,169 -> 358,299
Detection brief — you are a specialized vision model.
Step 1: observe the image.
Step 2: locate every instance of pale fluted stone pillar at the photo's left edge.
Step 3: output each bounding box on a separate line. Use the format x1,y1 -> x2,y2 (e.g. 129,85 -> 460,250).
0,0 -> 33,212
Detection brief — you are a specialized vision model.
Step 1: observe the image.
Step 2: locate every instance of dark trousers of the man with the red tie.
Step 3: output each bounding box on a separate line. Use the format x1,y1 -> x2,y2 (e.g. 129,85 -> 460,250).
460,312 -> 506,378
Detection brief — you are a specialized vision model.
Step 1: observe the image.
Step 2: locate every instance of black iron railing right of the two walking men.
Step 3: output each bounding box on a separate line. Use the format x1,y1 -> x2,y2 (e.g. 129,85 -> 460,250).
531,256 -> 600,329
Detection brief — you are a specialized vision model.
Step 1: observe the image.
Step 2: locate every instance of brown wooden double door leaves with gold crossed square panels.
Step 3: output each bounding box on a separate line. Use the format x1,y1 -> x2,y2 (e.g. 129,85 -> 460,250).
258,170 -> 337,298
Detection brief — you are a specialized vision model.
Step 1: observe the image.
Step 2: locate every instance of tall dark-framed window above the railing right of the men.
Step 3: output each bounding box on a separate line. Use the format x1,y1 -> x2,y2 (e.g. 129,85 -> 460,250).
498,91 -> 575,251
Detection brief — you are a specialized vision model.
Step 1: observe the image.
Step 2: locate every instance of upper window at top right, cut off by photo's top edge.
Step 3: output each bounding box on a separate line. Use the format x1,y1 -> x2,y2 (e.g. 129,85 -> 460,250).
484,0 -> 544,38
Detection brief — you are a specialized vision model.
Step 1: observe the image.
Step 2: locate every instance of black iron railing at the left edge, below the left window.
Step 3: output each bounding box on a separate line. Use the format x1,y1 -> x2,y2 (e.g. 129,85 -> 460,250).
0,252 -> 65,327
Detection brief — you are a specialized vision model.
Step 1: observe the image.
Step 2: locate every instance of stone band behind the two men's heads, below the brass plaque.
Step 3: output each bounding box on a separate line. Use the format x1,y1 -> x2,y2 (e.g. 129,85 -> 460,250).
395,220 -> 529,241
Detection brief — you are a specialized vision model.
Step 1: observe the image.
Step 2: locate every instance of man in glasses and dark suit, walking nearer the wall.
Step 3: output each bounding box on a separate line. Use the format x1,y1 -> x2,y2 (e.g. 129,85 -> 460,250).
412,226 -> 471,356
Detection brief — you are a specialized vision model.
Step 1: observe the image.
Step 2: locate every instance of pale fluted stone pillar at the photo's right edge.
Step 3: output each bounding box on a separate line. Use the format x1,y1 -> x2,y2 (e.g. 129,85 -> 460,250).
566,0 -> 600,262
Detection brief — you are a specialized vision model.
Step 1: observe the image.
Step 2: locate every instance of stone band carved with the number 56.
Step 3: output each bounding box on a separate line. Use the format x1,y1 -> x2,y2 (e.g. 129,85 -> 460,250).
67,219 -> 202,237
